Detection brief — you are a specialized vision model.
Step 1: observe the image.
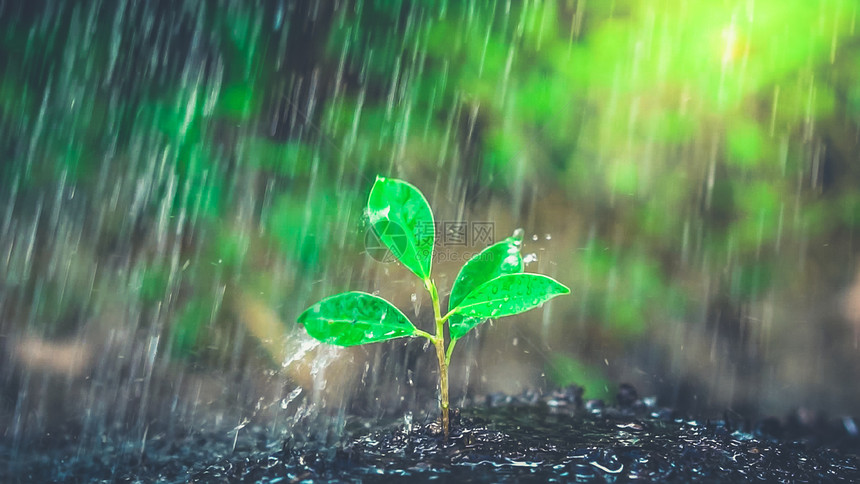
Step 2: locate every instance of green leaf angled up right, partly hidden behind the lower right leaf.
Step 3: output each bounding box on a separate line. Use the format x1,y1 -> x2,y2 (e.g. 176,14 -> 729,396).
448,229 -> 523,336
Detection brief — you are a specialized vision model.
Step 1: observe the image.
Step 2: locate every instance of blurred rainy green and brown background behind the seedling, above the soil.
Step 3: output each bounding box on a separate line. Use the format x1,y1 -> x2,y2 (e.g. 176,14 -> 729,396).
0,0 -> 860,438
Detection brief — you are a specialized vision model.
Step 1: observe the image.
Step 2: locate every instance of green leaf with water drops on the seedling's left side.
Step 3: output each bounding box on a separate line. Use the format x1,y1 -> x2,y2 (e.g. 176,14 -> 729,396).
298,291 -> 416,346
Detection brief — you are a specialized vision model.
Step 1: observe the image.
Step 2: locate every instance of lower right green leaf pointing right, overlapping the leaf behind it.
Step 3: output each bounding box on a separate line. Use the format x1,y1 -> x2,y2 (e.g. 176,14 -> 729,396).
449,274 -> 570,339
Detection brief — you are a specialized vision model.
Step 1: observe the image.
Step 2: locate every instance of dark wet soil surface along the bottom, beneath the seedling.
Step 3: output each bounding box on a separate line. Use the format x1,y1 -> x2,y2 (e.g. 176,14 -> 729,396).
0,386 -> 860,483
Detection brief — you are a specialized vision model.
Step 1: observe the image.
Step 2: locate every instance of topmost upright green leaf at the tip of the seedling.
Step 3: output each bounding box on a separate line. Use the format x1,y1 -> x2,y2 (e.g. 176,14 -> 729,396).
367,176 -> 436,281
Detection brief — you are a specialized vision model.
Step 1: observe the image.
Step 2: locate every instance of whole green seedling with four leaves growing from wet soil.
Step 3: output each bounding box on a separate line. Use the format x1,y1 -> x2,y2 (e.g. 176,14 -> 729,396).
298,177 -> 570,439
